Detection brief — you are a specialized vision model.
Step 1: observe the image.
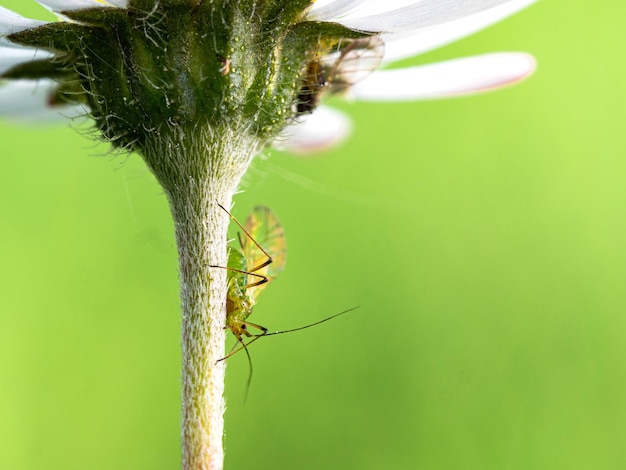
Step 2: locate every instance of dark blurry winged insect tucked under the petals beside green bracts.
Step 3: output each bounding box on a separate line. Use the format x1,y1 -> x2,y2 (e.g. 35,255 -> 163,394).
296,36 -> 385,114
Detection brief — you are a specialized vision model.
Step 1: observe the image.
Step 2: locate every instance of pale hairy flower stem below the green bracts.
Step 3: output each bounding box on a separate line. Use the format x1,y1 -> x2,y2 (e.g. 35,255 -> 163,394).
144,125 -> 258,470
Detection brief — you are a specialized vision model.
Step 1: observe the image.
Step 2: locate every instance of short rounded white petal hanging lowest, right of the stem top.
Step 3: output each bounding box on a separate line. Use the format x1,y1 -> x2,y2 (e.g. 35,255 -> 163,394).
274,106 -> 352,154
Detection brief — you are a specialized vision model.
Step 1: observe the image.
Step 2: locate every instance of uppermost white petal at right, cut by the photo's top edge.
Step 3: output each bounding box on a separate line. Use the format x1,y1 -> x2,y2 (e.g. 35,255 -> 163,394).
339,0 -> 524,33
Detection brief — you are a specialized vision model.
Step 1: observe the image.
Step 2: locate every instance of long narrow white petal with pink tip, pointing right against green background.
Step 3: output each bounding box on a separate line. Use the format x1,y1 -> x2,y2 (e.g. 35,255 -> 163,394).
349,52 -> 535,101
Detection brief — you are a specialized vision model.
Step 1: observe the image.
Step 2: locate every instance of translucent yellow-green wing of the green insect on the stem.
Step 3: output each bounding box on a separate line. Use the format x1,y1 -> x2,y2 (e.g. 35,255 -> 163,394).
242,206 -> 286,300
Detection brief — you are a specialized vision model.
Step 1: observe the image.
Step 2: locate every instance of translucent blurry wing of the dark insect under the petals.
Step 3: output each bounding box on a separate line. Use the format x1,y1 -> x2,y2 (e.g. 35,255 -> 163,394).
322,36 -> 385,92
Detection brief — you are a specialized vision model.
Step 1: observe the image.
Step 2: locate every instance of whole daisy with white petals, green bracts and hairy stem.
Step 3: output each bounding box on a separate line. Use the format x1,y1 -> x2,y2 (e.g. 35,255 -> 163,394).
0,0 -> 534,469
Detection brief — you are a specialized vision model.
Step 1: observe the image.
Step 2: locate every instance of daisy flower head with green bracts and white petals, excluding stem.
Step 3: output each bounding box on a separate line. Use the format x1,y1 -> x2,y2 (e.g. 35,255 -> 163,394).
0,0 -> 534,155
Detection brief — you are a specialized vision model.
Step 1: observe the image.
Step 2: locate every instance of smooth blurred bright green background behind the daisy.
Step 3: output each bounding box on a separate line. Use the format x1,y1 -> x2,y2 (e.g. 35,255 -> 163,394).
0,0 -> 626,470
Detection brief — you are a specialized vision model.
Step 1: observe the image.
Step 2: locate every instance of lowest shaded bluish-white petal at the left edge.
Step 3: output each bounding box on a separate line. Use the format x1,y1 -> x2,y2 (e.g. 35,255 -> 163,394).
0,80 -> 86,122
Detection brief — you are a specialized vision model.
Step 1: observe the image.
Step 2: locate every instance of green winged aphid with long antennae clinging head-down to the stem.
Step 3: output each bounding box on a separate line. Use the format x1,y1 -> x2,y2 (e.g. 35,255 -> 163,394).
210,205 -> 357,385
